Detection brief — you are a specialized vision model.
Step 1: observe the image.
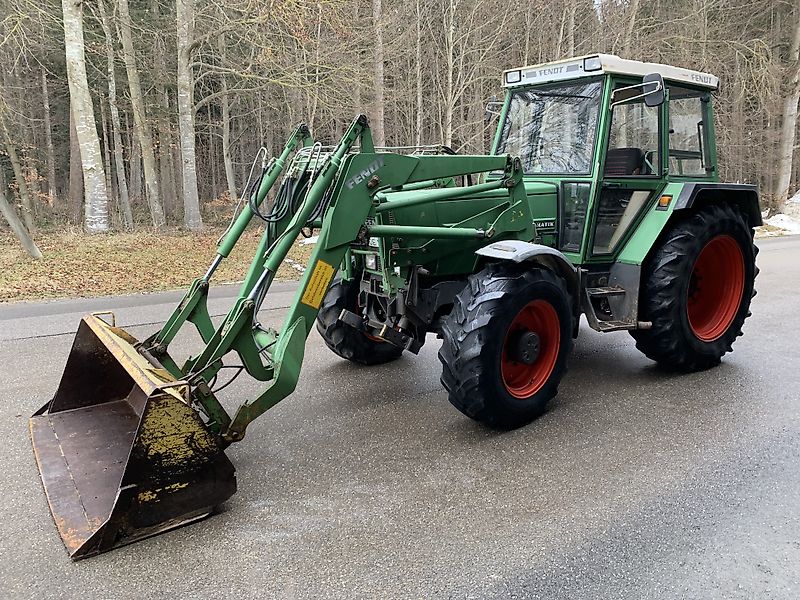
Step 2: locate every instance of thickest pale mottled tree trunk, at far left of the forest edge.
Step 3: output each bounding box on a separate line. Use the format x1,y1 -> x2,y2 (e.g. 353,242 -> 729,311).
61,0 -> 108,233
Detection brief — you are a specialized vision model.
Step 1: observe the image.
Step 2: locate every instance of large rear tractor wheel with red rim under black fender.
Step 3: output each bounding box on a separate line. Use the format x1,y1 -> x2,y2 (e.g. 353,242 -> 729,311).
631,204 -> 758,372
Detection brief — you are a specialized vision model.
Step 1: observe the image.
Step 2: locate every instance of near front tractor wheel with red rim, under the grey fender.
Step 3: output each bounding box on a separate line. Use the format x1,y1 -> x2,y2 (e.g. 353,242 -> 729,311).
439,264 -> 574,429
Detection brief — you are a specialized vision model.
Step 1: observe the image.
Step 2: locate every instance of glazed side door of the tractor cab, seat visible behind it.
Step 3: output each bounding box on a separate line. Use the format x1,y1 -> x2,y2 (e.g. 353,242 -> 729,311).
587,80 -> 666,262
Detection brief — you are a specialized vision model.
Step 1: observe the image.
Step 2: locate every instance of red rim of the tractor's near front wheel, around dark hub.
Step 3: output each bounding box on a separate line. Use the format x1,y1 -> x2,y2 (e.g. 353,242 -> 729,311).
500,300 -> 561,400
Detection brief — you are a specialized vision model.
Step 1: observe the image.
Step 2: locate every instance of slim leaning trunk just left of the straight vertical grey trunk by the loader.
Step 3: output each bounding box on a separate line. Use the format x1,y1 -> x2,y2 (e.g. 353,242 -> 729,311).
118,0 -> 166,229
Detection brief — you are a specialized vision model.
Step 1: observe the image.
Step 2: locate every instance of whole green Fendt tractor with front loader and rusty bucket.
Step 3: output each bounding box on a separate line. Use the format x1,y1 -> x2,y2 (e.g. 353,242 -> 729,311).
30,54 -> 761,558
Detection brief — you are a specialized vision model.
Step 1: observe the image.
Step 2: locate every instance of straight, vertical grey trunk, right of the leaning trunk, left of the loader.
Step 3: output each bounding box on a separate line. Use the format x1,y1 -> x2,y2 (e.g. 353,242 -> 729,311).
176,0 -> 203,231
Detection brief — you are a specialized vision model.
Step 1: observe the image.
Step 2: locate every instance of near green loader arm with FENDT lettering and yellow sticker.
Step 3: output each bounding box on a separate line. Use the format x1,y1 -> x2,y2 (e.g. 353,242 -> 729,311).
168,116 -> 530,443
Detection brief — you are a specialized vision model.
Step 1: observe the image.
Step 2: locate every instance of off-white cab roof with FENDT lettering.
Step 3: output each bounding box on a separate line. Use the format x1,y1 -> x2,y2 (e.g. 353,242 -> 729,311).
503,54 -> 719,90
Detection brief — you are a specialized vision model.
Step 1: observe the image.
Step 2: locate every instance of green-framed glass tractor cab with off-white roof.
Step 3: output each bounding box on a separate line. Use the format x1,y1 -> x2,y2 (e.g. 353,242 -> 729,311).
493,54 -> 719,264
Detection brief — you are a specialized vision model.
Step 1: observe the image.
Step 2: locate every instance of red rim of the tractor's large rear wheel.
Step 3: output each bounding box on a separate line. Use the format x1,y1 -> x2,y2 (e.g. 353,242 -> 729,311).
687,235 -> 744,342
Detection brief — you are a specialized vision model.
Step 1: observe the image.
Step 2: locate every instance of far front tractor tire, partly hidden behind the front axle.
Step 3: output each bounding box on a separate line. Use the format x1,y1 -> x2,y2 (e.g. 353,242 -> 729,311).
317,277 -> 403,366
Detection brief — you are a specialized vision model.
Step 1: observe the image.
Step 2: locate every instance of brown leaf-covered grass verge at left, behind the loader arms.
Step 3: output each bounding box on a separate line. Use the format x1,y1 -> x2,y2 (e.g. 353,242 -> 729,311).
0,227 -> 313,302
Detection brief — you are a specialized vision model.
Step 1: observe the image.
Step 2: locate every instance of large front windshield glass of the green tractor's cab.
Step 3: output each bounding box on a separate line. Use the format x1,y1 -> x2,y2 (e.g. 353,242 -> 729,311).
497,81 -> 602,175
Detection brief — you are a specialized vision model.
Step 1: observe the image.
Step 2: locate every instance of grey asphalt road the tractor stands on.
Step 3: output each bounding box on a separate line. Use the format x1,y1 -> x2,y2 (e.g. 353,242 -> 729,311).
0,237 -> 800,600
